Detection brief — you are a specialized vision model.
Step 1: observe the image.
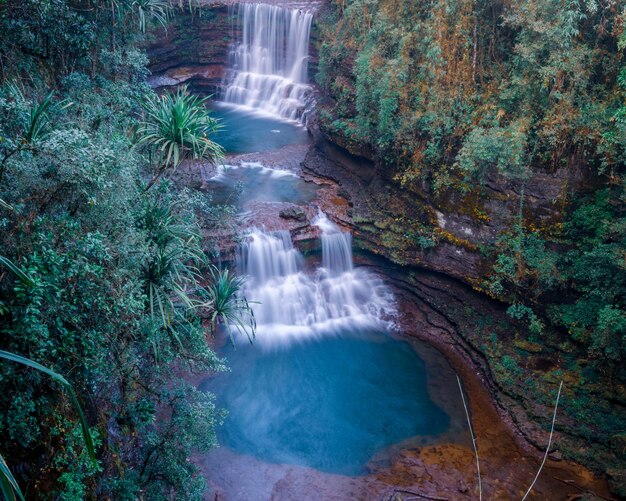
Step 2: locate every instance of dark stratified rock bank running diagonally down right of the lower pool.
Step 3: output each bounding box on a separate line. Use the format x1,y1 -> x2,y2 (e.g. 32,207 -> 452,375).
303,136 -> 623,499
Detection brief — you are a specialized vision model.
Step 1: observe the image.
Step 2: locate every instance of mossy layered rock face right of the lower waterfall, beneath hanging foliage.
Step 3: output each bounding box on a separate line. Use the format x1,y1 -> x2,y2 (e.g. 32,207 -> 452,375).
303,135 -> 584,285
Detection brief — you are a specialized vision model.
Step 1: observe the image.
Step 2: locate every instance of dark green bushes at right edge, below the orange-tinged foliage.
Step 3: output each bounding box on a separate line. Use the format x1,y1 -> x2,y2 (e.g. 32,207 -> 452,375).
487,187 -> 626,378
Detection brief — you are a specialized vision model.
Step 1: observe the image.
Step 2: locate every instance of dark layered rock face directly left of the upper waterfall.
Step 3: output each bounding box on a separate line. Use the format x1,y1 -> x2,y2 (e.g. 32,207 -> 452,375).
147,4 -> 237,94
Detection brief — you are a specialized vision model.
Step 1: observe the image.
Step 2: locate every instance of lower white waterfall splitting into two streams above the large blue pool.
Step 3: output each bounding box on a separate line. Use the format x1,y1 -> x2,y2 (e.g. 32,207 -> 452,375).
238,211 -> 394,346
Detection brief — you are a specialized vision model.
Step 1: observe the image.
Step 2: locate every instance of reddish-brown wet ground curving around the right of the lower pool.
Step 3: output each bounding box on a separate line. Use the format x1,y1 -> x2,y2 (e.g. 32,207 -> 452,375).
378,288 -> 611,500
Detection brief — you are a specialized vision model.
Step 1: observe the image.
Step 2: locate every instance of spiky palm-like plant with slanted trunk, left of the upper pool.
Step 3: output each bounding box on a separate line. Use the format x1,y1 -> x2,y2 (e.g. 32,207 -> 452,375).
137,86 -> 224,190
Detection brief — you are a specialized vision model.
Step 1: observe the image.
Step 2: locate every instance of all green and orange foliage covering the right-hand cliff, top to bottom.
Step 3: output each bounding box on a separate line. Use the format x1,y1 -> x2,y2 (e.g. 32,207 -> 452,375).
317,0 -> 626,480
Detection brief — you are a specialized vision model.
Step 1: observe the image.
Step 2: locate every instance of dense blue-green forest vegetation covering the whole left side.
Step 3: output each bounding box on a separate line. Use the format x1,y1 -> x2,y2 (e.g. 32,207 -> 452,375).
0,0 -> 252,500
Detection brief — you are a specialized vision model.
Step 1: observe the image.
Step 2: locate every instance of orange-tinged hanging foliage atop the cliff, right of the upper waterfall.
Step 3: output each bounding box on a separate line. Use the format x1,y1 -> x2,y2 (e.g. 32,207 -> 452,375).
317,0 -> 624,185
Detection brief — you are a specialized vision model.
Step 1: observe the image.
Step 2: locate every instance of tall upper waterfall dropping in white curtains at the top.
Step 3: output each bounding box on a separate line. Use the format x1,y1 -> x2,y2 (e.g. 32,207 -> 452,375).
223,3 -> 313,120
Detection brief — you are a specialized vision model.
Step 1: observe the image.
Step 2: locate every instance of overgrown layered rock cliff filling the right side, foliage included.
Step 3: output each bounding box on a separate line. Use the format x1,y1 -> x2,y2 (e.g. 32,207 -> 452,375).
304,0 -> 626,495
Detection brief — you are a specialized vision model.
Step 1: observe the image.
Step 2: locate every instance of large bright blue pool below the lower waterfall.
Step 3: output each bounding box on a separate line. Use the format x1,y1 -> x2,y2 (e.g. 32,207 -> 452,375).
202,332 -> 449,475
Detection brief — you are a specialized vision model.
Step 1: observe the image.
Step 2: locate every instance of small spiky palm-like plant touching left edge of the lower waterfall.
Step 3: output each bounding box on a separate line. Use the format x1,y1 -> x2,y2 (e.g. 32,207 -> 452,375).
198,267 -> 256,343
